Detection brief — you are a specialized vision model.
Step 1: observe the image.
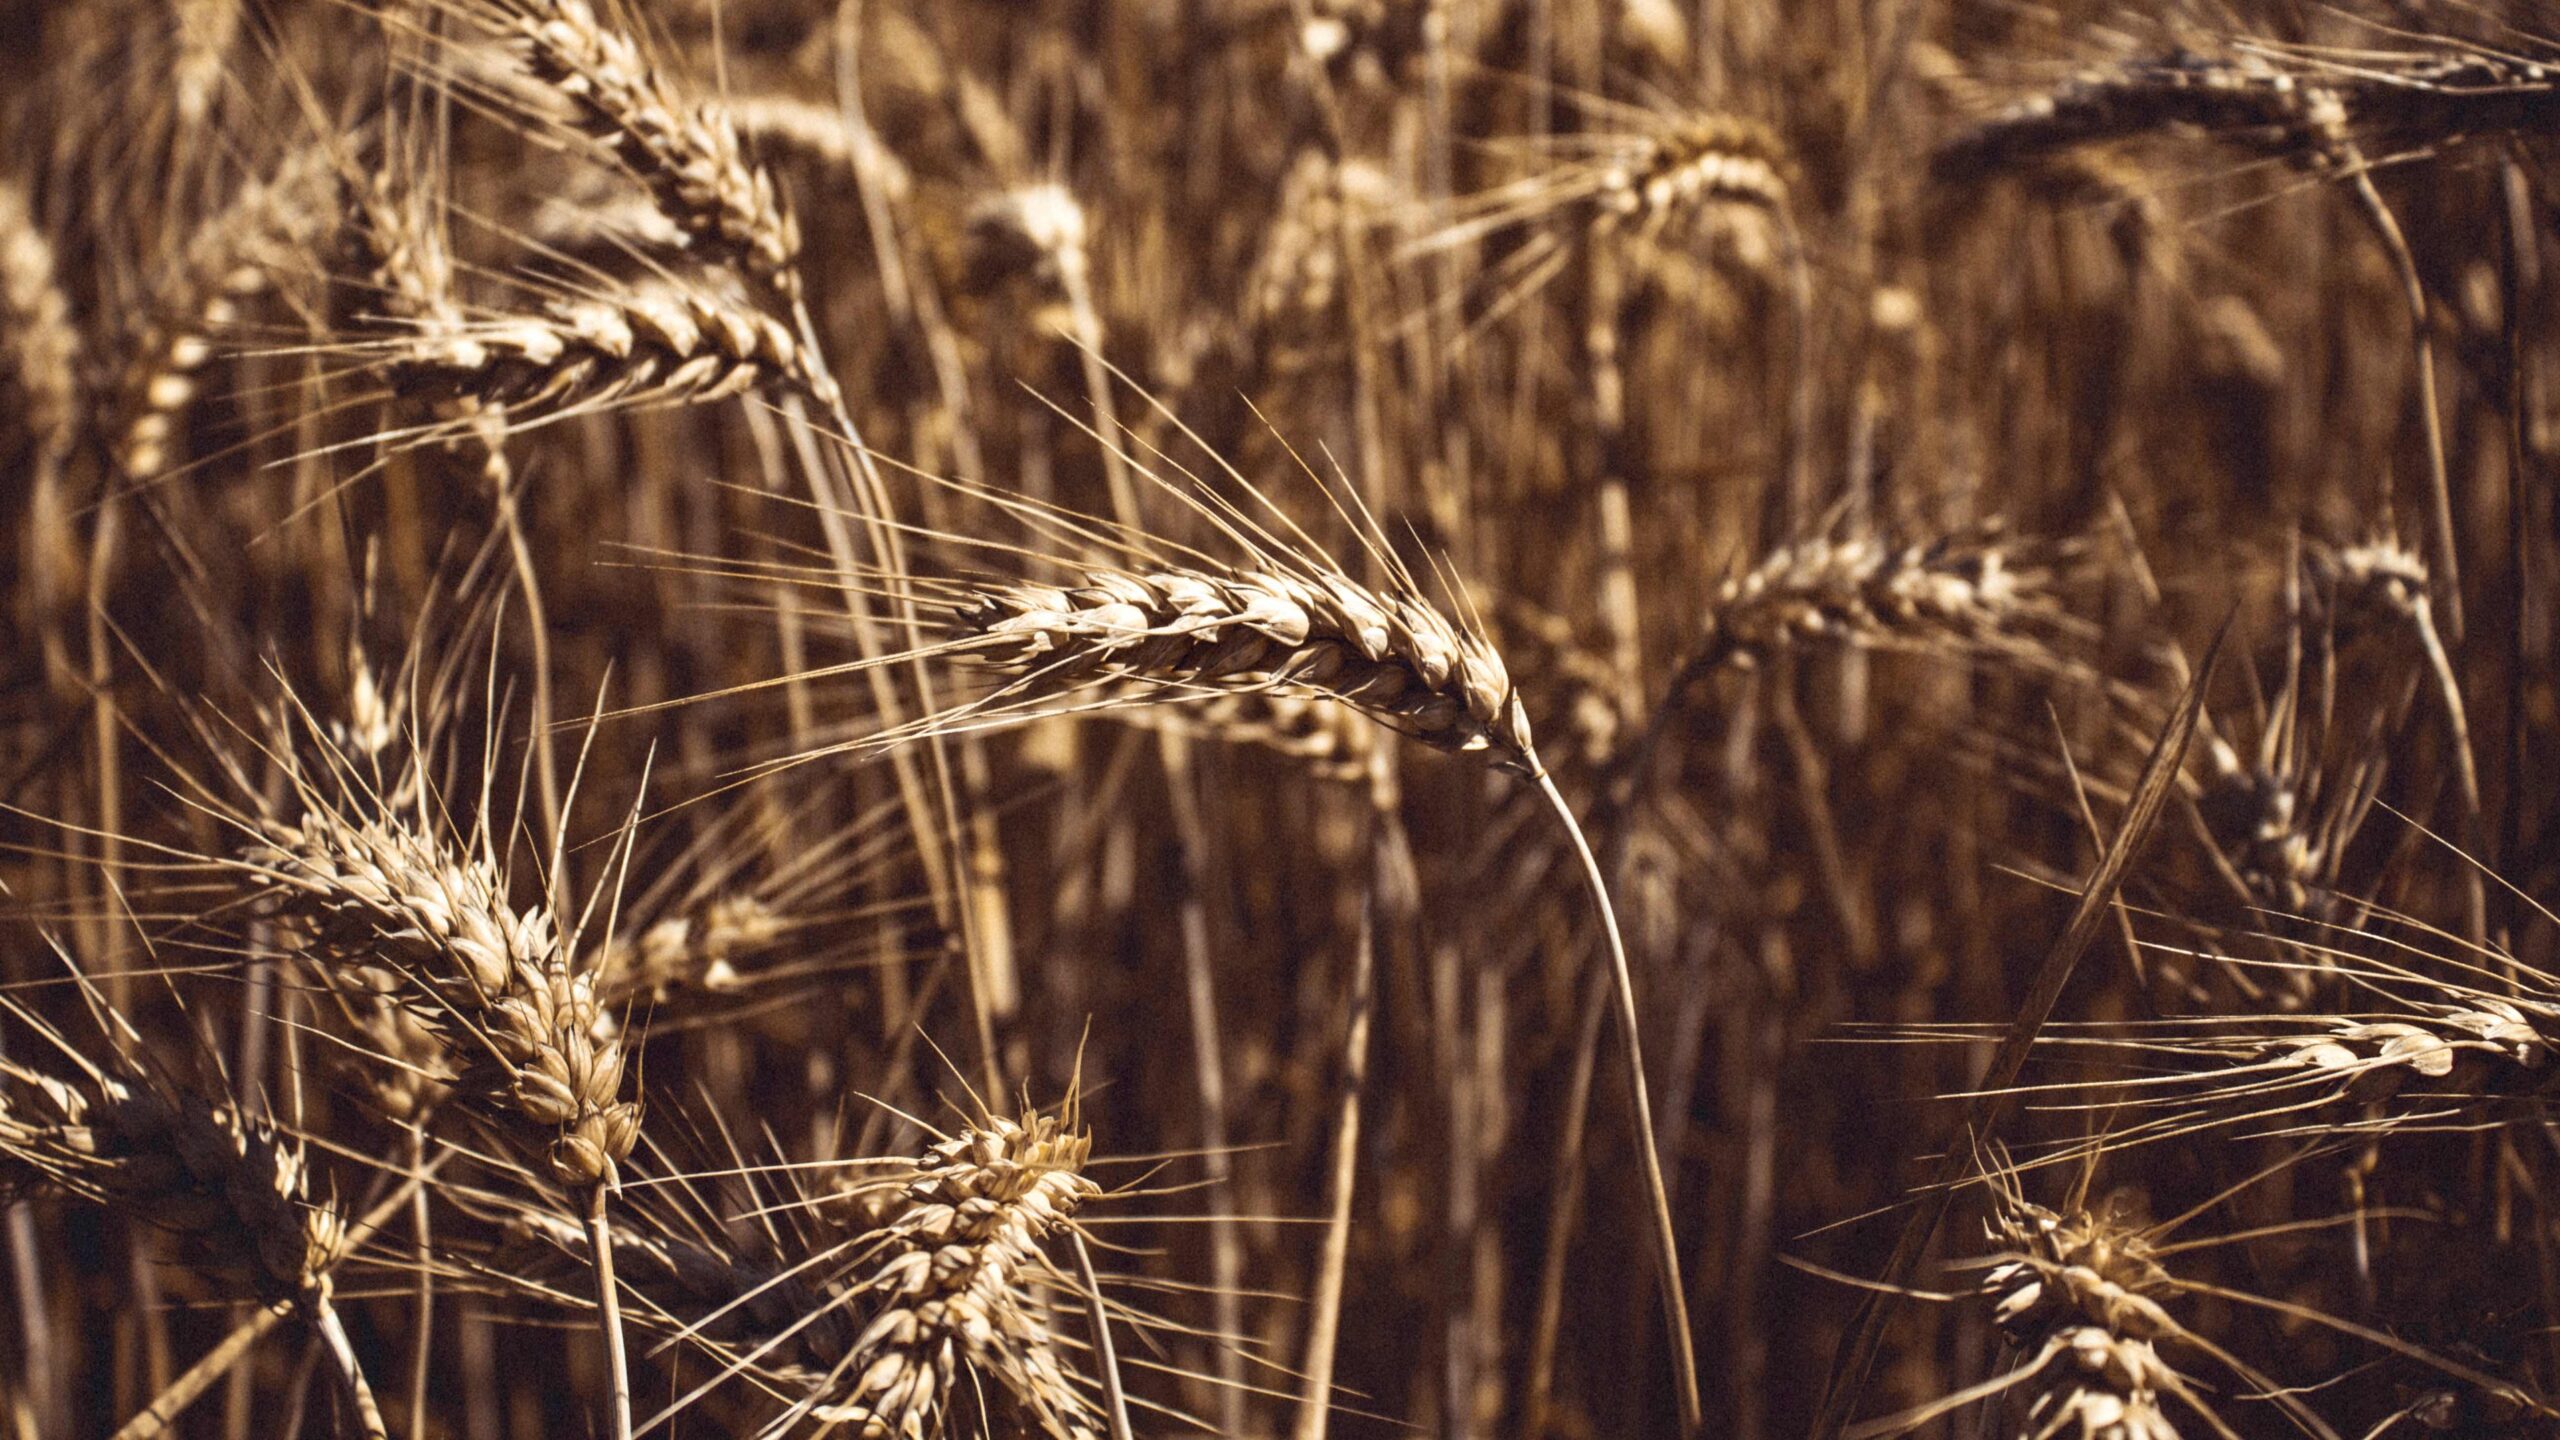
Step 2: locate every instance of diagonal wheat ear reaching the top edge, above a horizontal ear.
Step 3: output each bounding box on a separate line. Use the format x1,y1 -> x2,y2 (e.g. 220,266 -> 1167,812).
435,0 -> 801,302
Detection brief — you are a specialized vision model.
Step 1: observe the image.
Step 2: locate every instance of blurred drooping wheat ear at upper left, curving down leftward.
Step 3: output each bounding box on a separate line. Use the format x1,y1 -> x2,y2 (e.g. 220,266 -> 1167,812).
115,143 -> 340,479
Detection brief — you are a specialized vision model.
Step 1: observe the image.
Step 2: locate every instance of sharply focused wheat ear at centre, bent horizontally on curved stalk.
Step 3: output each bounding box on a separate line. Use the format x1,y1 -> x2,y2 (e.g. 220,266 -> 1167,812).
957,569 -> 1541,776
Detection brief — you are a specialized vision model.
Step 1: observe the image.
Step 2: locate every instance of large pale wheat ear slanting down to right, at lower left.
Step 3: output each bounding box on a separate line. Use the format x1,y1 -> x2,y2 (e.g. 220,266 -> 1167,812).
238,807 -> 640,1186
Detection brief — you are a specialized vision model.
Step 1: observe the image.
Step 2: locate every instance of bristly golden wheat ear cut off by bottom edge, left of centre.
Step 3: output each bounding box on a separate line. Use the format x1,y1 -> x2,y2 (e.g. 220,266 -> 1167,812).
804,1115 -> 1101,1440
